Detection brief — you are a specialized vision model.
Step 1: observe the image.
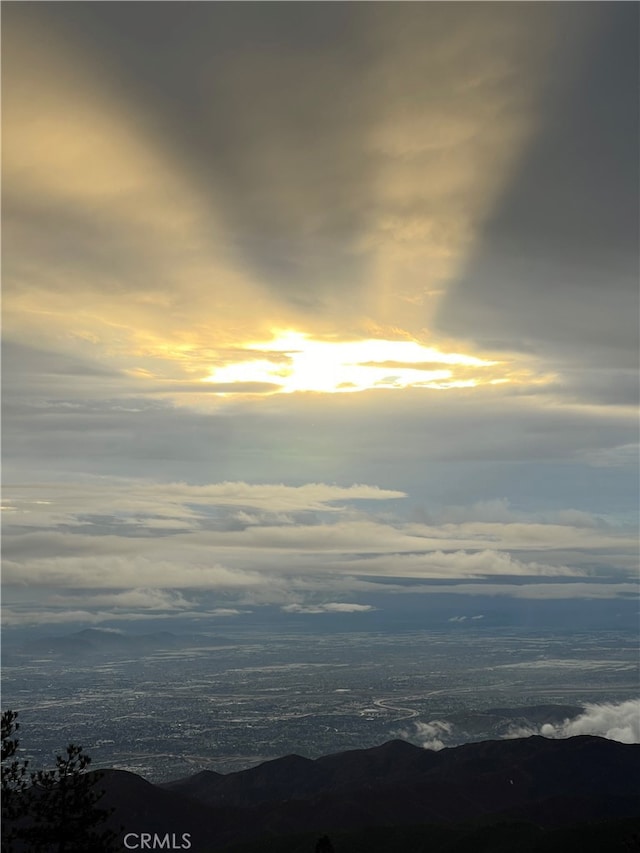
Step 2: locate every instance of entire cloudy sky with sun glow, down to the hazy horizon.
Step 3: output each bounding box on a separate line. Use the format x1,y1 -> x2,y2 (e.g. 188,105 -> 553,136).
2,2 -> 639,631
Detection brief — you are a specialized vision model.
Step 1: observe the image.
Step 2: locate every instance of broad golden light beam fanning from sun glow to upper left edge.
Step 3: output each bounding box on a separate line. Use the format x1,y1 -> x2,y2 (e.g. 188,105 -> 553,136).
3,15 -> 282,362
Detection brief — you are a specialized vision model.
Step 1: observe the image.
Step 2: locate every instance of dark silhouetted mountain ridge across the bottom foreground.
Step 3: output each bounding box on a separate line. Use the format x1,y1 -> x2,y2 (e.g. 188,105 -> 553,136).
86,736 -> 640,853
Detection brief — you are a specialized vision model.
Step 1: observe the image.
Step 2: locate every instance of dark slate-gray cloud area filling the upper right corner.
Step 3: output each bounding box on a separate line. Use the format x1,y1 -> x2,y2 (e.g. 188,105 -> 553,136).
438,3 -> 640,370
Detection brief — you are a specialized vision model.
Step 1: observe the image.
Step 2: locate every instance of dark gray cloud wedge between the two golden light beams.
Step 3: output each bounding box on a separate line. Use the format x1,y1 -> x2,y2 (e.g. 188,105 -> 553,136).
5,3 -> 377,310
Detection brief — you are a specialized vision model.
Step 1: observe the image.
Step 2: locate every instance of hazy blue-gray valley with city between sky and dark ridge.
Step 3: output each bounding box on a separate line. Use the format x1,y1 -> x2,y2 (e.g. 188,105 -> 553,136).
3,630 -> 640,781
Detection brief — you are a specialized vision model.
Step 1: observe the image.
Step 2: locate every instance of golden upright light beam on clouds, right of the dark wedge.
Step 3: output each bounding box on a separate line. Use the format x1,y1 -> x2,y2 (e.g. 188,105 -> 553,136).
360,3 -> 576,335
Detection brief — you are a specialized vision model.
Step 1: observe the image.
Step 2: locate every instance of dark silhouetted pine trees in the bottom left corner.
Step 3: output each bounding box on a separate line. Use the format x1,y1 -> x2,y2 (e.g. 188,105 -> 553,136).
2,711 -> 120,853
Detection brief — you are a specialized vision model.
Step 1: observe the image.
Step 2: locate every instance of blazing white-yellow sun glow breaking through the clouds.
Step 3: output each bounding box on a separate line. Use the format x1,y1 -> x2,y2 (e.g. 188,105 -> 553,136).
204,331 -> 503,393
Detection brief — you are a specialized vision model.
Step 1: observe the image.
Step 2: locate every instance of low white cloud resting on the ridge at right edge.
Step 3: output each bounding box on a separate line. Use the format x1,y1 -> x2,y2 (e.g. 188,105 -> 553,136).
504,699 -> 640,743
